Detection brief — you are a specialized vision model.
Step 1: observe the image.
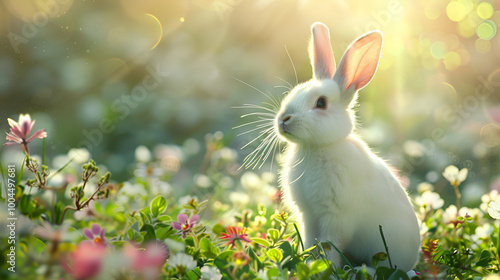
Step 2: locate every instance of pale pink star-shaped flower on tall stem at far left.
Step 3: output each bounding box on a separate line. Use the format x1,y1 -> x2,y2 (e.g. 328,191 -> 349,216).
4,114 -> 47,154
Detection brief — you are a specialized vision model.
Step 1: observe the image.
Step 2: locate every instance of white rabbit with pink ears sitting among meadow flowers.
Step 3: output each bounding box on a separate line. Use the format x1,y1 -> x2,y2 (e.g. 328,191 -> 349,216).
274,23 -> 420,271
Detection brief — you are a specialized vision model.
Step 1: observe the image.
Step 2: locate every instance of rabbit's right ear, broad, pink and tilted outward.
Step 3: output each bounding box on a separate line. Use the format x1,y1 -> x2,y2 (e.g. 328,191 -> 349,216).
333,31 -> 384,105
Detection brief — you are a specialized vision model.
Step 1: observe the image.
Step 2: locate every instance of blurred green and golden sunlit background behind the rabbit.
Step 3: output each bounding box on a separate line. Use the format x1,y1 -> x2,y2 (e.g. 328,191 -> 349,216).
0,0 -> 500,200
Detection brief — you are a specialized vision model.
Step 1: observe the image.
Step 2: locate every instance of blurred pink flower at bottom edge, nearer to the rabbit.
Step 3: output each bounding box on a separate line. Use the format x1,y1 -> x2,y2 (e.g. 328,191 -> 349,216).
124,241 -> 170,279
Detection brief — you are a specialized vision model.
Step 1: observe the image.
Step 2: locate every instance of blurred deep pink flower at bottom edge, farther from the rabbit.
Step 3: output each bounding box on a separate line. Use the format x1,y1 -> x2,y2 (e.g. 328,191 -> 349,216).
62,242 -> 106,279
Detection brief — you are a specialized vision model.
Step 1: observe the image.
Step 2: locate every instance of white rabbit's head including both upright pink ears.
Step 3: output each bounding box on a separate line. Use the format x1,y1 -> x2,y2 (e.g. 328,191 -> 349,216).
275,22 -> 383,146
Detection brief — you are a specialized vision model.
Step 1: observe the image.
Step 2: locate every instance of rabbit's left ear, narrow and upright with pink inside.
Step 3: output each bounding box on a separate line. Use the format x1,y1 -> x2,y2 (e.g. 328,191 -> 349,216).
309,22 -> 335,80
